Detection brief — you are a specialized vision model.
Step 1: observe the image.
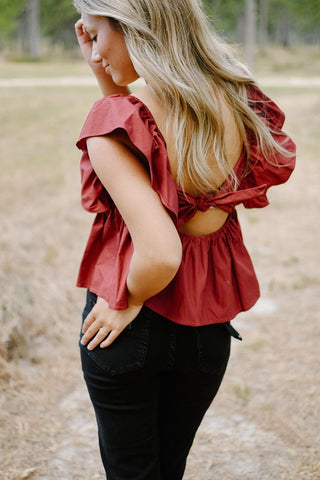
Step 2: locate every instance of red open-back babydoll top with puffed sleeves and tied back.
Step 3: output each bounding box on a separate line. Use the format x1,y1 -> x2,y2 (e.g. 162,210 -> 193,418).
77,85 -> 295,326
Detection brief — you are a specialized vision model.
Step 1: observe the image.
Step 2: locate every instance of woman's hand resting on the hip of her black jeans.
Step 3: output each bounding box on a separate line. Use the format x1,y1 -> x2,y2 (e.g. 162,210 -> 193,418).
81,297 -> 142,350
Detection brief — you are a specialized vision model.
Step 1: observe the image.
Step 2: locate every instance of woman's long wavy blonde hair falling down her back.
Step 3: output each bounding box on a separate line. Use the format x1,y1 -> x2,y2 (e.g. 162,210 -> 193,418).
74,0 -> 287,193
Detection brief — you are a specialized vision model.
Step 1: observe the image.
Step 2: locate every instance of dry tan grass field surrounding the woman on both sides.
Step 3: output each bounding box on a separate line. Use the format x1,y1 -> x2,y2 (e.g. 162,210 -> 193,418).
0,49 -> 320,480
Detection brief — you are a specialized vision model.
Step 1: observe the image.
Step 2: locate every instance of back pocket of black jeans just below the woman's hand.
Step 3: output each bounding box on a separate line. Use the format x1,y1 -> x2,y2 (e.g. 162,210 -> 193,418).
80,308 -> 150,375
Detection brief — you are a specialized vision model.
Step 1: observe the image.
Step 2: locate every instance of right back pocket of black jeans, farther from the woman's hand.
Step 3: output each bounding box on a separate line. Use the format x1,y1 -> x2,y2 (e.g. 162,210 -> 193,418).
196,323 -> 231,374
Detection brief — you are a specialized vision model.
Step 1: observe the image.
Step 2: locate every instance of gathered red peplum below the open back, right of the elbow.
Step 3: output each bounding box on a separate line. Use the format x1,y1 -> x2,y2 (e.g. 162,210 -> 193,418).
145,210 -> 260,327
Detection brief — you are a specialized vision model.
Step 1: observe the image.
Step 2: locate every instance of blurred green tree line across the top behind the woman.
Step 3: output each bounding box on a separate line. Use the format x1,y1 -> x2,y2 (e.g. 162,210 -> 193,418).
0,0 -> 320,63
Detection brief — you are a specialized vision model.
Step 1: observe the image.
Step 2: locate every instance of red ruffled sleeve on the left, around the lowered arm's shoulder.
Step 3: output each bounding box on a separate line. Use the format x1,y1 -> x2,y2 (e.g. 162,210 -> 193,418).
77,95 -> 178,220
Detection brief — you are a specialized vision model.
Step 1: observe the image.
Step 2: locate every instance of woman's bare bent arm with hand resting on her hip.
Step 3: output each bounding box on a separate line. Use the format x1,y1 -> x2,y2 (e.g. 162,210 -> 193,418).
83,136 -> 182,348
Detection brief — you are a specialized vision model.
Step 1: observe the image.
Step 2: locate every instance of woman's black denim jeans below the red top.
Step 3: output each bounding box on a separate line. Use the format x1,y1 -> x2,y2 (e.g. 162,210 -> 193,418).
80,292 -> 236,480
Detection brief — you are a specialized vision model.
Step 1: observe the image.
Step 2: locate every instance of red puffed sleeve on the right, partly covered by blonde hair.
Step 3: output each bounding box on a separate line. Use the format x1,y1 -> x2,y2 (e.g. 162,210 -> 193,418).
239,85 -> 296,208
